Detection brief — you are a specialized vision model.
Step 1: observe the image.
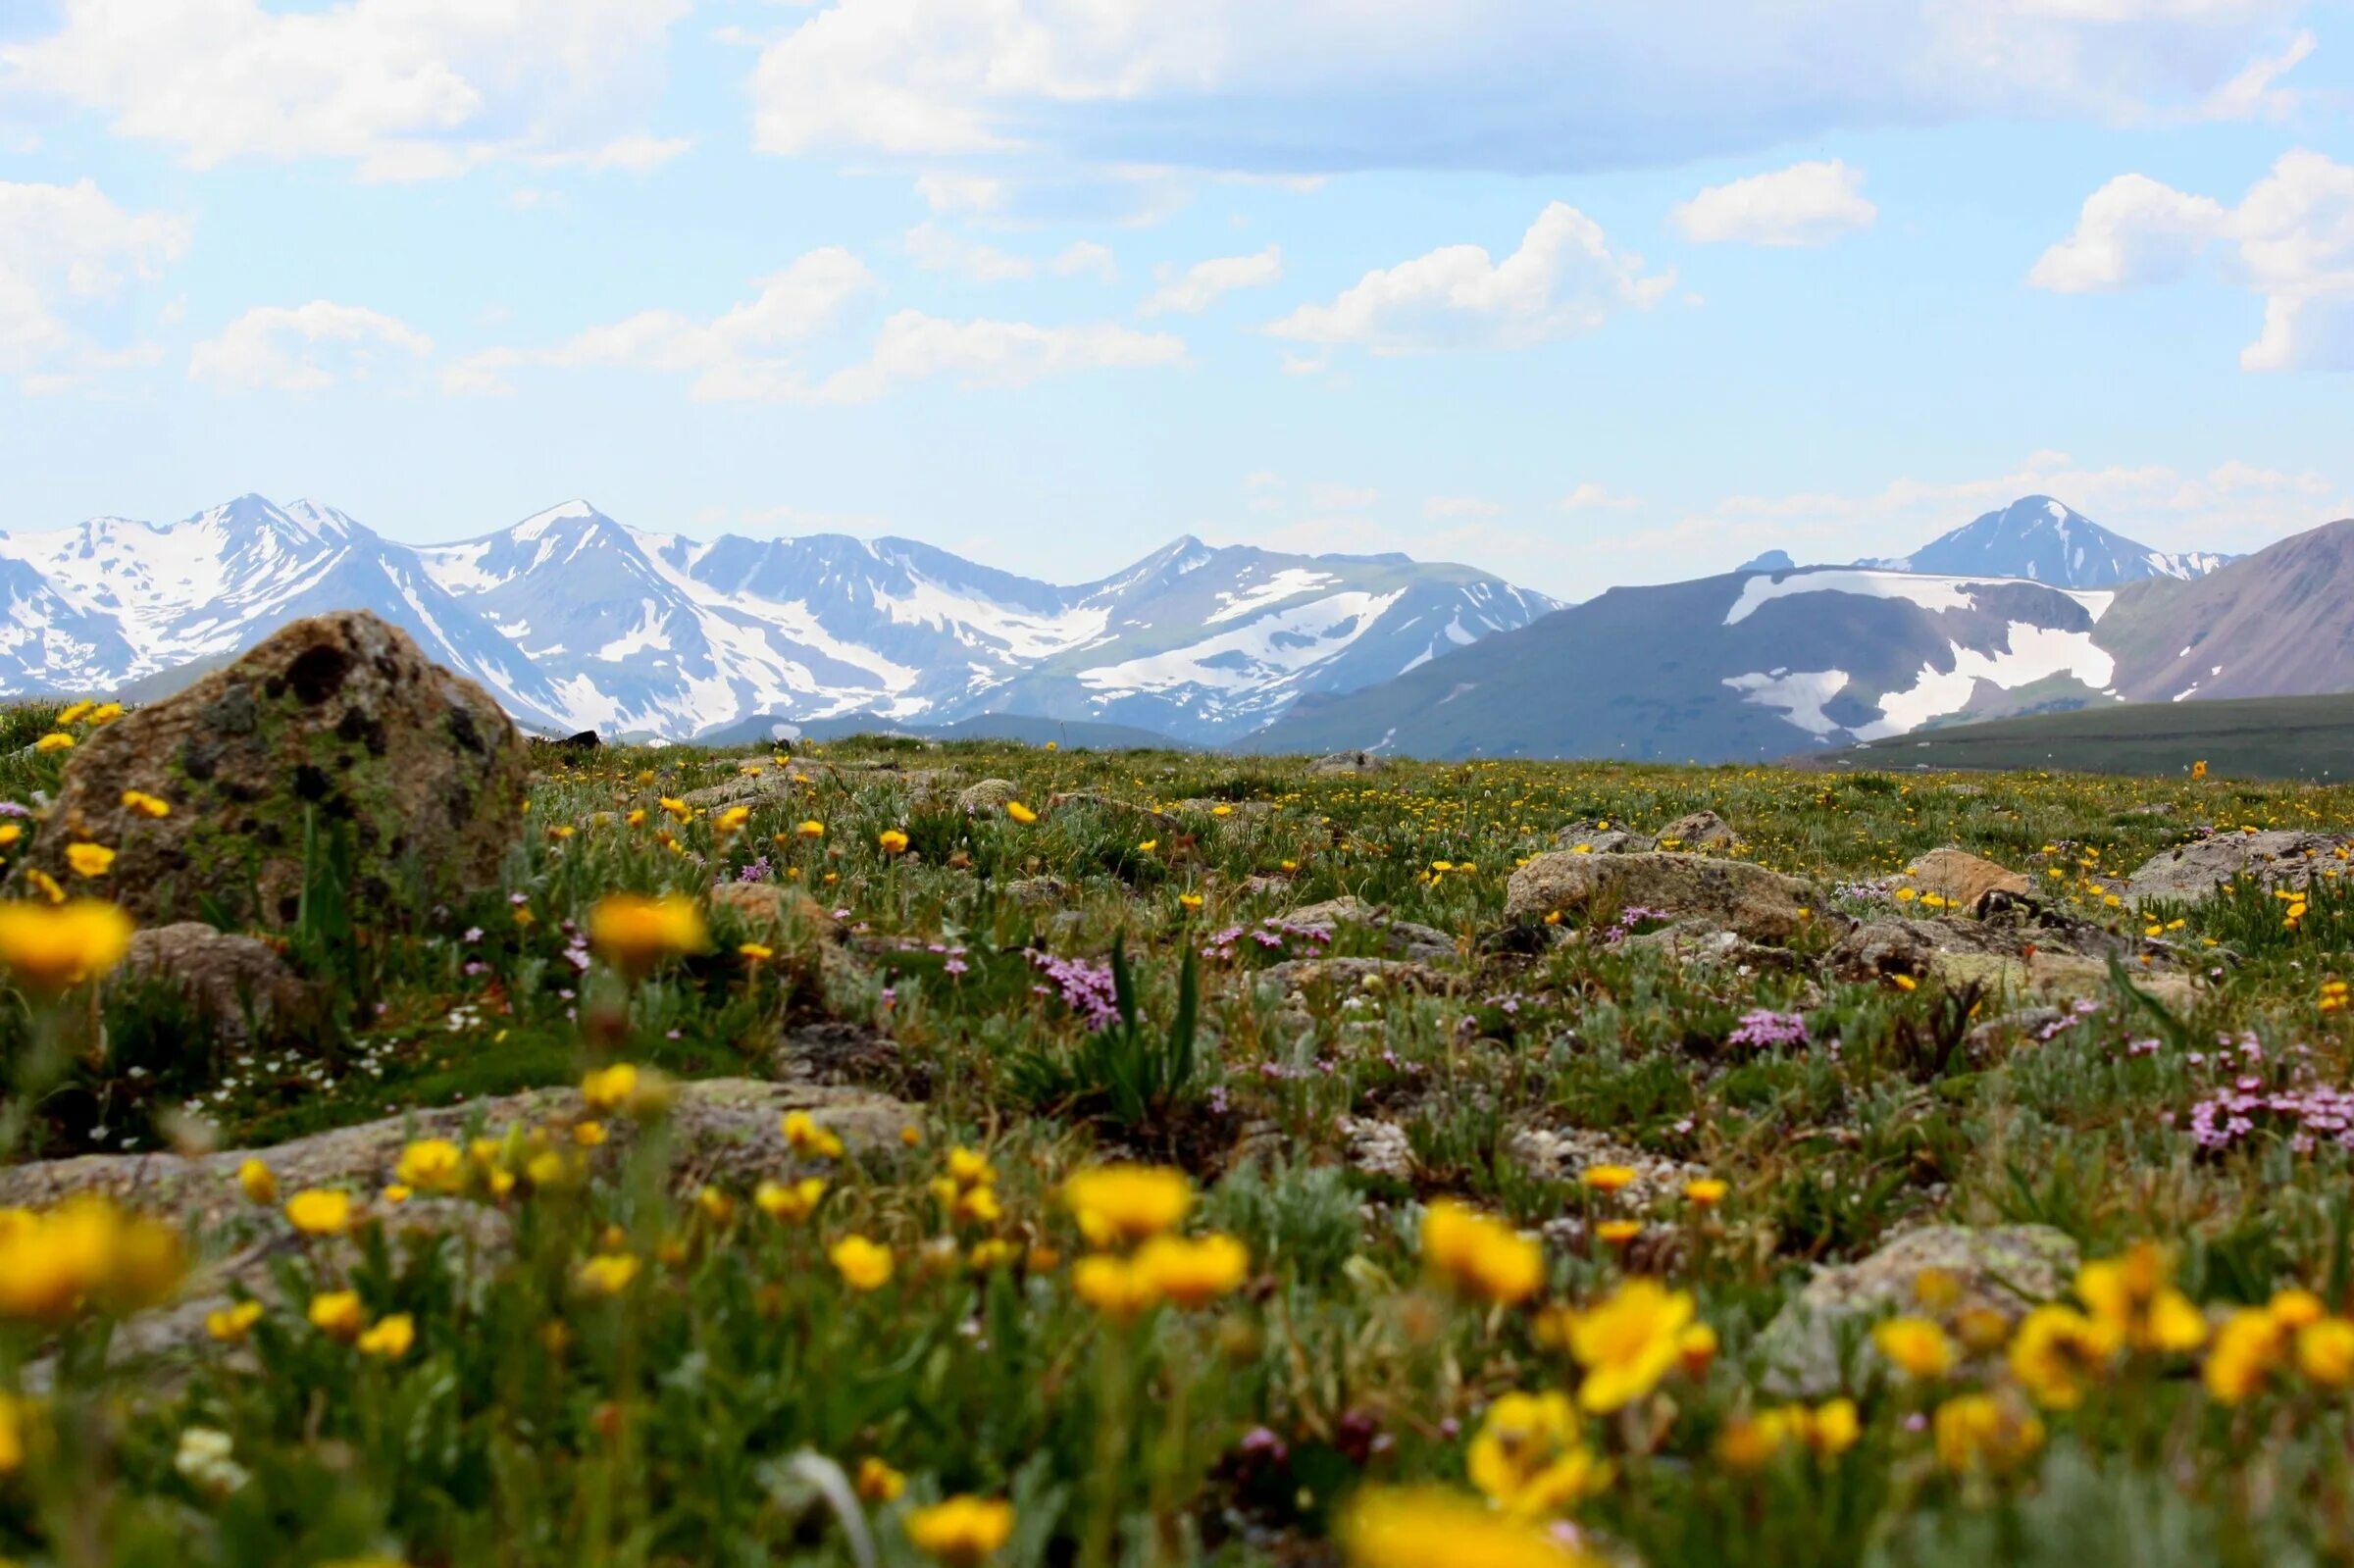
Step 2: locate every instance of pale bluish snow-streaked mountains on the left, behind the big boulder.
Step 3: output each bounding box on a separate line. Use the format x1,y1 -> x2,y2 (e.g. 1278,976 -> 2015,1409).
0,494 -> 1556,741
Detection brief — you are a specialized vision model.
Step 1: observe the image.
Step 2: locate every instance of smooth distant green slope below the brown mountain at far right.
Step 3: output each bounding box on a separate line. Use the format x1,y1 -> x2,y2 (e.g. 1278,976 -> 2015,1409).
1806,692 -> 2354,782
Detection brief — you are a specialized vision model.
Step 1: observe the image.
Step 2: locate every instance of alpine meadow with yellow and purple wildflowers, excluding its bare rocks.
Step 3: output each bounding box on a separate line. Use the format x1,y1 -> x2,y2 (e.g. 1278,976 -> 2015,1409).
0,704 -> 2354,1568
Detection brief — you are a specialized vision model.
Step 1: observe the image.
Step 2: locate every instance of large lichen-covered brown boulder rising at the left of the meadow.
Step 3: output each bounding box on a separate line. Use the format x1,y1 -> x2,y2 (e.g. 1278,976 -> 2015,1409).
28,610 -> 530,926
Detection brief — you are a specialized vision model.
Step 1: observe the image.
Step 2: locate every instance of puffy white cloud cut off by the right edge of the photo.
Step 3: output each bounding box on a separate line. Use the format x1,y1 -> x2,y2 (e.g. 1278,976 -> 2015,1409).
2026,151 -> 2354,370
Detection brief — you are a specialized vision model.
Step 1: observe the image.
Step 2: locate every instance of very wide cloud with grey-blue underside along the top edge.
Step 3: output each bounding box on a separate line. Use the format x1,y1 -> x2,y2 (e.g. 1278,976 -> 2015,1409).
753,0 -> 2319,175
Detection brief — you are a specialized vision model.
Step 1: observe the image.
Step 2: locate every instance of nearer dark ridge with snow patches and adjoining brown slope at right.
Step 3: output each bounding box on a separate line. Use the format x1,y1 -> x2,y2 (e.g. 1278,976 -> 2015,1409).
1250,509 -> 2354,763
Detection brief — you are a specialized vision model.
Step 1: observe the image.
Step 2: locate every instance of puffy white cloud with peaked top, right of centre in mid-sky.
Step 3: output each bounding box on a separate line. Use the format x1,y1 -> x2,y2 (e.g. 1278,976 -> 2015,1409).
1266,202 -> 1676,356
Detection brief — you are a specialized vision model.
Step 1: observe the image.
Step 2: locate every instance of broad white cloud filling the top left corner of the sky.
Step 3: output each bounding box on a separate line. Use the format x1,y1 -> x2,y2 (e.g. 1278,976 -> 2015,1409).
0,0 -> 688,178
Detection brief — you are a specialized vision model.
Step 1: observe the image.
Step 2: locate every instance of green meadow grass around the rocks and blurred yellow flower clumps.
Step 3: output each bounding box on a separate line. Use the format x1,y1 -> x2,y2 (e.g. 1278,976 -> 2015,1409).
0,725 -> 2354,1568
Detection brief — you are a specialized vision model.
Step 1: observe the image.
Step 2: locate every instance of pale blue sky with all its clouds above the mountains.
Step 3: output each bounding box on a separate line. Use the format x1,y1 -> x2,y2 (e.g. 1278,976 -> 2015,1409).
0,0 -> 2354,598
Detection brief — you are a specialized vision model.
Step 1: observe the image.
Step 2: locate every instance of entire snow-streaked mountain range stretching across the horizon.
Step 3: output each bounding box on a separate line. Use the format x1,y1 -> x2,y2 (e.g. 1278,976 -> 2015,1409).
0,494 -> 2326,760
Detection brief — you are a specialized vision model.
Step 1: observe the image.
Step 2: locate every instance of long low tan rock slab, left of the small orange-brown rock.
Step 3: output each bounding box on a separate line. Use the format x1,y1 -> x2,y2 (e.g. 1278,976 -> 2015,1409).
1505,850 -> 1822,941
